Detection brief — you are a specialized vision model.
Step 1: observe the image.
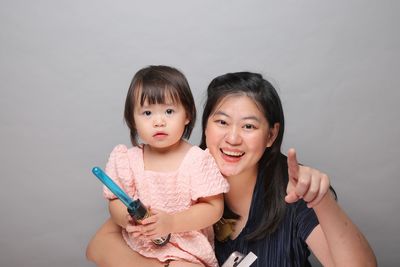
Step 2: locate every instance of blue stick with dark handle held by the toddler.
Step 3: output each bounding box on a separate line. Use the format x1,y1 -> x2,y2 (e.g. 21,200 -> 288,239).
92,167 -> 171,246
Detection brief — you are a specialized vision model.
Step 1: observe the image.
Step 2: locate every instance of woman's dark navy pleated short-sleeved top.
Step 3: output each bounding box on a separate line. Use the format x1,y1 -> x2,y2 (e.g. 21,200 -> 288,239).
215,160 -> 318,267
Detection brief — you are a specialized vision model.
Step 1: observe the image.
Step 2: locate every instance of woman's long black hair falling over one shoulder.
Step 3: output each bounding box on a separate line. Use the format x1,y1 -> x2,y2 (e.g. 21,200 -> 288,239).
200,72 -> 288,240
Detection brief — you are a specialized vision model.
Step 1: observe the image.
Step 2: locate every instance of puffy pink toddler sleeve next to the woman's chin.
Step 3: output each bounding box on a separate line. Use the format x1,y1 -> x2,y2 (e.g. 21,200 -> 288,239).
190,148 -> 229,200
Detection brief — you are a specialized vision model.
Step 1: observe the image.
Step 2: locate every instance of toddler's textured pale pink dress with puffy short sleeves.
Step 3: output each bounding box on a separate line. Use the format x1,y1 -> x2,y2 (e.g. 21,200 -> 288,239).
104,145 -> 229,266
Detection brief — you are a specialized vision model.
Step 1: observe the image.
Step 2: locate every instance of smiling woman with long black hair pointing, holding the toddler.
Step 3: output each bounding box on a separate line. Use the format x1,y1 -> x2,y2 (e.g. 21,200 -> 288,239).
87,72 -> 376,266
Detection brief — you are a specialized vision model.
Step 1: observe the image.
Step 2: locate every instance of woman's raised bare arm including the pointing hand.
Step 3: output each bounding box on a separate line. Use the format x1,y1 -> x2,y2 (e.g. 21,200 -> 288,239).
286,149 -> 377,267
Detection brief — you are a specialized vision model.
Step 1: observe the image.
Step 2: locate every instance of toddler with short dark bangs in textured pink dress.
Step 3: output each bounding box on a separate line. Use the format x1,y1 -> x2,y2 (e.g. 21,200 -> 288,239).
104,66 -> 229,266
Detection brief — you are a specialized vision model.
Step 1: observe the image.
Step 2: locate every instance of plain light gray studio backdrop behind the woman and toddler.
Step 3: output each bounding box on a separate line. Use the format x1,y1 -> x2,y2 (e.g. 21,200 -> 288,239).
0,0 -> 400,267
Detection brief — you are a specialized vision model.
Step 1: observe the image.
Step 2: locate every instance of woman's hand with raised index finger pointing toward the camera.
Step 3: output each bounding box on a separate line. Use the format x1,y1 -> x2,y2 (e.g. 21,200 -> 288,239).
285,148 -> 330,208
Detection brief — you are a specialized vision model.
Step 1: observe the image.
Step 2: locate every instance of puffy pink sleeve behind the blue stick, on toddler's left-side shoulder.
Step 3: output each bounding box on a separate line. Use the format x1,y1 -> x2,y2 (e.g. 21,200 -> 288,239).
103,145 -> 135,199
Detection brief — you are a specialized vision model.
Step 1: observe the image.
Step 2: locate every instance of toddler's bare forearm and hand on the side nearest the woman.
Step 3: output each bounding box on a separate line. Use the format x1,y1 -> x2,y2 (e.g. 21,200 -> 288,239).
139,194 -> 224,239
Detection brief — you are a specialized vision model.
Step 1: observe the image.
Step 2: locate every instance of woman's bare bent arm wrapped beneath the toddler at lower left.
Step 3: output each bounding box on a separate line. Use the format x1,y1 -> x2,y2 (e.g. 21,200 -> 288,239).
86,219 -> 164,267
